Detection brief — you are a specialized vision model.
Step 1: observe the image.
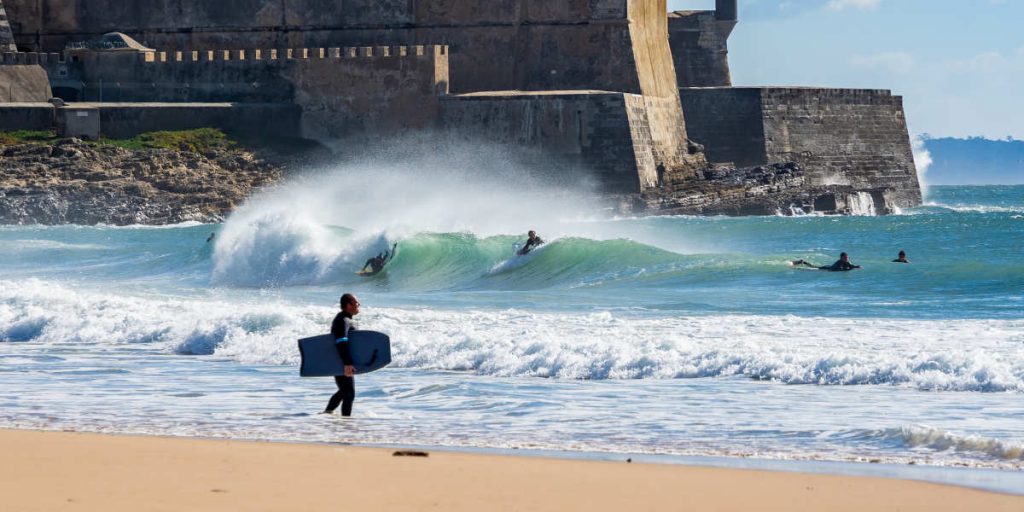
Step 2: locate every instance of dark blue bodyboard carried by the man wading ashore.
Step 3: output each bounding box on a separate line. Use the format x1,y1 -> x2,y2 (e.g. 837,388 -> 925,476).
299,331 -> 391,377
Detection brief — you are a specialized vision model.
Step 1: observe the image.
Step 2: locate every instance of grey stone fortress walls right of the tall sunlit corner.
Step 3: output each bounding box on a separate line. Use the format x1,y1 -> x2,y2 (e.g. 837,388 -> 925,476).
669,0 -> 922,212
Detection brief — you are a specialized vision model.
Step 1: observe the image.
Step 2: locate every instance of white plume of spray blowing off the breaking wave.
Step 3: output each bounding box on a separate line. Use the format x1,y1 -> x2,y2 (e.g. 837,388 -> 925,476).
213,144 -> 602,286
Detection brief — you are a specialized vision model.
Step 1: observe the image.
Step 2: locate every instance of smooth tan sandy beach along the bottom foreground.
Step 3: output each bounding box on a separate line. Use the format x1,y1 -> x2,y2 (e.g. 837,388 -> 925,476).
0,430 -> 1024,512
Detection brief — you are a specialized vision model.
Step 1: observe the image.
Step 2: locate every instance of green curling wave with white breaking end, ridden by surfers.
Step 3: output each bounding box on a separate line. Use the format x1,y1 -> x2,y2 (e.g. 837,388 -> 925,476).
213,221 -> 683,290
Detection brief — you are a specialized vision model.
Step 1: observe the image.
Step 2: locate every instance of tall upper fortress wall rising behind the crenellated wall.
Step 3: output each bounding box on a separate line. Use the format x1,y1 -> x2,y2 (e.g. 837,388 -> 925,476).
6,0 -> 675,95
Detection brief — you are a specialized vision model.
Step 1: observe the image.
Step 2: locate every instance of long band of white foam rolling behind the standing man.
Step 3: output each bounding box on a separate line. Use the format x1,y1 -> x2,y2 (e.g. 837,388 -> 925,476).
0,281 -> 1024,392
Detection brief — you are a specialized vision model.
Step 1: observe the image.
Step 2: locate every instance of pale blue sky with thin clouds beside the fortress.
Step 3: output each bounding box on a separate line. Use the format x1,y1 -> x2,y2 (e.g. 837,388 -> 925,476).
669,0 -> 1024,139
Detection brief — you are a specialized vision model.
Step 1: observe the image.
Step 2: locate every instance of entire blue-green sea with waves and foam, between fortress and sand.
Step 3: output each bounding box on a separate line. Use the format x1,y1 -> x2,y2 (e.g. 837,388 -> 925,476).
0,180 -> 1024,469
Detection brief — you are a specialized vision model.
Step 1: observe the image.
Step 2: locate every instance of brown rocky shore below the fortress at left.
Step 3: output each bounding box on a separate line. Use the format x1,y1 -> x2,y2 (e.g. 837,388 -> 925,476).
0,139 -> 299,225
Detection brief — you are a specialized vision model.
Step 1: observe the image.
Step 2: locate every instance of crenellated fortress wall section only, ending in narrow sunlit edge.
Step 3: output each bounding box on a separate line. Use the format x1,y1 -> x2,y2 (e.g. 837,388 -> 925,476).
46,45 -> 449,141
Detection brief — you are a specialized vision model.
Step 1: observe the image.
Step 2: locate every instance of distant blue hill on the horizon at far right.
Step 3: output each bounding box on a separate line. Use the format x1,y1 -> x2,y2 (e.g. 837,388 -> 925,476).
925,136 -> 1024,185
